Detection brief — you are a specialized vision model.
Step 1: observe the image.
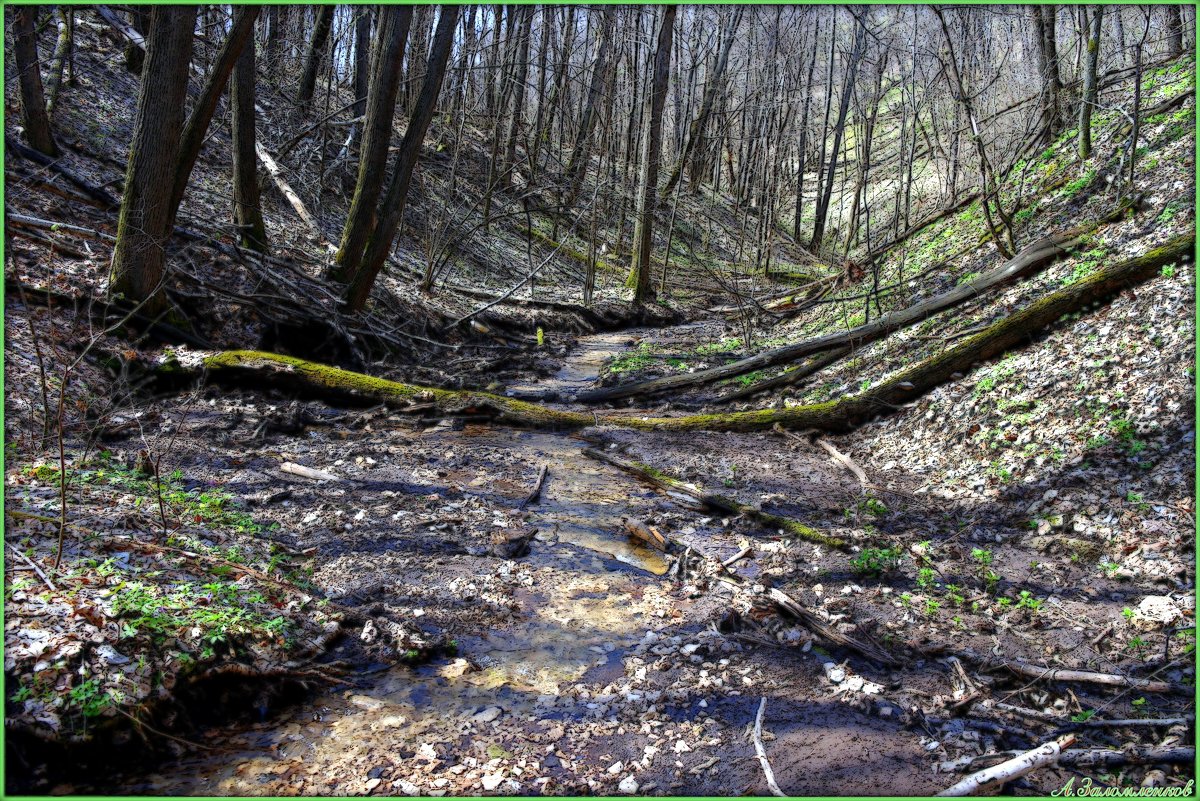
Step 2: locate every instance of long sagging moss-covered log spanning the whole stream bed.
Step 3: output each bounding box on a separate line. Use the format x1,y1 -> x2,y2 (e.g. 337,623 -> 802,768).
154,234 -> 1195,432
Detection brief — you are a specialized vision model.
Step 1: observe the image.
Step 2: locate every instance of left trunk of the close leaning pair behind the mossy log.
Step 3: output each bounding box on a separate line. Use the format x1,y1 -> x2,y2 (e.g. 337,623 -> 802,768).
330,6 -> 413,283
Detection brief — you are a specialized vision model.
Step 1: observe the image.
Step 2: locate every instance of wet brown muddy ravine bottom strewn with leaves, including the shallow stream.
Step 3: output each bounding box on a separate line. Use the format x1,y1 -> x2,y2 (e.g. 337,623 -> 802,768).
9,326 -> 1190,795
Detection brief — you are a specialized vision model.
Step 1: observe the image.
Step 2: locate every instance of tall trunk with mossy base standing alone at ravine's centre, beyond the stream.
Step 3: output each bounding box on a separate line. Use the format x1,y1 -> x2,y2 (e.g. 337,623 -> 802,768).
629,6 -> 676,303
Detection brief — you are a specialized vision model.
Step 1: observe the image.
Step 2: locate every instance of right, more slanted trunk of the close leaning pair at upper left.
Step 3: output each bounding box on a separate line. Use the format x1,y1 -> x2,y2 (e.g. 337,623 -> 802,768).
346,6 -> 458,312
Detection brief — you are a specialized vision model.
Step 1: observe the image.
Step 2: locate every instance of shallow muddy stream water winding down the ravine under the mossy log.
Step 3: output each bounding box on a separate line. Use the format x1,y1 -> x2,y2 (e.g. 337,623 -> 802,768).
115,333 -> 700,795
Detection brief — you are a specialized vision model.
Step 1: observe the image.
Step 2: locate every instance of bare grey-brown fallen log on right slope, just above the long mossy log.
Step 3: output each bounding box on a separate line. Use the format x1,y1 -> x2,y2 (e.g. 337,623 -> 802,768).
578,196 -> 1130,403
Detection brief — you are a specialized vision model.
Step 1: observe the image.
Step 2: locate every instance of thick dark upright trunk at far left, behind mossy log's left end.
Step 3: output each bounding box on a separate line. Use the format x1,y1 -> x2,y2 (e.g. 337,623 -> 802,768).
109,6 -> 197,314
